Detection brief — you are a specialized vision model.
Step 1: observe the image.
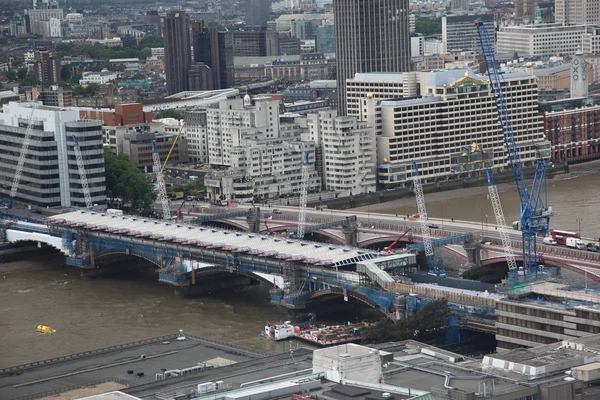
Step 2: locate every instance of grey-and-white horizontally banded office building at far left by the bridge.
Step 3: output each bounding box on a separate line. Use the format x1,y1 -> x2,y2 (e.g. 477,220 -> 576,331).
0,102 -> 106,208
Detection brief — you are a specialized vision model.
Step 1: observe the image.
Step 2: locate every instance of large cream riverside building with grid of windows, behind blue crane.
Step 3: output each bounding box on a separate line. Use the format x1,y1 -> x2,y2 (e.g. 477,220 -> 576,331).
359,69 -> 550,188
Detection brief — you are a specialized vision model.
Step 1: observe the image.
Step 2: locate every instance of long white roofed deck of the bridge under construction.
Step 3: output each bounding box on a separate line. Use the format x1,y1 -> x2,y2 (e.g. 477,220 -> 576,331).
46,211 -> 381,265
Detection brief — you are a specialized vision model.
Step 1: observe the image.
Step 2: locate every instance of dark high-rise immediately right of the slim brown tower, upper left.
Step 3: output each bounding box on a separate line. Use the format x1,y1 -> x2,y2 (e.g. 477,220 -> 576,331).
190,21 -> 233,90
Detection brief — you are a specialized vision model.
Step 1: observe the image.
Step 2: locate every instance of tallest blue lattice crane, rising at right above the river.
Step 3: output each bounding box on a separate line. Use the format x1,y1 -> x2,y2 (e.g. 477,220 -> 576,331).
476,21 -> 552,274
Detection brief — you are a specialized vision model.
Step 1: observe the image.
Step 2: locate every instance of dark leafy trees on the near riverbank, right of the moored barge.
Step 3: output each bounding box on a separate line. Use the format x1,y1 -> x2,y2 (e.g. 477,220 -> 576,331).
362,299 -> 452,344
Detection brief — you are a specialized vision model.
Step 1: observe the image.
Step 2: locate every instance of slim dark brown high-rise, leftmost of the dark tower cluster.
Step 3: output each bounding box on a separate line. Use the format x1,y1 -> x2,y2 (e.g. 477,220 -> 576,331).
162,11 -> 191,94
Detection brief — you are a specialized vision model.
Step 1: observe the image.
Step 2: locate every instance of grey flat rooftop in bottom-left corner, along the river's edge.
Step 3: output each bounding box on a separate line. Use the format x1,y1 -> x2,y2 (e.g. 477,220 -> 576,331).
0,335 -> 268,400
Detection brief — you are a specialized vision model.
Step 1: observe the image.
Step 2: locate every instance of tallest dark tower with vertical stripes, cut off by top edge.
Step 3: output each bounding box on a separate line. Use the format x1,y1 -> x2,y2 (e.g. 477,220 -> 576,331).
333,0 -> 410,115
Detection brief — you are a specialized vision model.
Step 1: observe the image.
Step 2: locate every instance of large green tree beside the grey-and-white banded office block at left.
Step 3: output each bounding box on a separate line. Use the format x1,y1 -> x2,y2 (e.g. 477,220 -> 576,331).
104,147 -> 156,213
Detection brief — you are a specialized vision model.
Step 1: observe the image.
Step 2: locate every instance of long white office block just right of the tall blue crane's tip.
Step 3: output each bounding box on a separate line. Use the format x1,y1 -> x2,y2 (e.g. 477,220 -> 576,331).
496,24 -> 600,57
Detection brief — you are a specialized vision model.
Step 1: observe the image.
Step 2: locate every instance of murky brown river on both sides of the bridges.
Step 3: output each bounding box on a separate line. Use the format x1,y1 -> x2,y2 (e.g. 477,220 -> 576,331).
0,167 -> 600,367
